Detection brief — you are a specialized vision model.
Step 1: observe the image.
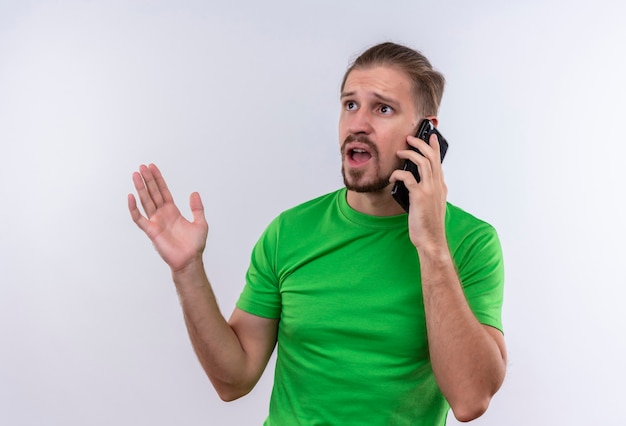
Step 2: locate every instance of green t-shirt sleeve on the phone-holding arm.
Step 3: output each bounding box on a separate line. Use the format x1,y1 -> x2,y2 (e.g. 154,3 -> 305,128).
455,224 -> 504,331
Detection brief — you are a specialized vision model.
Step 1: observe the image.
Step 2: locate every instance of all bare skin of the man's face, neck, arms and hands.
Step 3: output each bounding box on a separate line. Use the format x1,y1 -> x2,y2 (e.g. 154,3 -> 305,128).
128,62 -> 506,421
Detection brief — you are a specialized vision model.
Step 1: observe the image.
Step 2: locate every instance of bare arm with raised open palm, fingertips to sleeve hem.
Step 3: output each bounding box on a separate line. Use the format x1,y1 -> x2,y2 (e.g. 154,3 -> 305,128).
128,164 -> 278,401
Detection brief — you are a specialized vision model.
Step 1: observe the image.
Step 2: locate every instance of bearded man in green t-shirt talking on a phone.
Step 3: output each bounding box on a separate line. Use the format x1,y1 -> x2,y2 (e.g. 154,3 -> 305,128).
129,43 -> 506,426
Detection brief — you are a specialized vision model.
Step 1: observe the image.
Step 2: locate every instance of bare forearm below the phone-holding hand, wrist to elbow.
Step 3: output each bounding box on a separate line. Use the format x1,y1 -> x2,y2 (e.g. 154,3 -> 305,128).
420,247 -> 505,421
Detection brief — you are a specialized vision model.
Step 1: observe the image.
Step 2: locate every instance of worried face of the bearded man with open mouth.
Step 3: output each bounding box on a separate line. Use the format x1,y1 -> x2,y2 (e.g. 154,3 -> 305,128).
339,66 -> 419,192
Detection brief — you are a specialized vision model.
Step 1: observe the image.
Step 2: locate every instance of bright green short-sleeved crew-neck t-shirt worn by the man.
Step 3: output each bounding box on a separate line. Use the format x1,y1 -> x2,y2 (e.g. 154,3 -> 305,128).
237,189 -> 503,426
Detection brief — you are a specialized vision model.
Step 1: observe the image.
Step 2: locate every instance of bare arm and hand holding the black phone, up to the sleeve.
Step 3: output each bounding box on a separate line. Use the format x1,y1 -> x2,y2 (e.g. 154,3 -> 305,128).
391,135 -> 506,421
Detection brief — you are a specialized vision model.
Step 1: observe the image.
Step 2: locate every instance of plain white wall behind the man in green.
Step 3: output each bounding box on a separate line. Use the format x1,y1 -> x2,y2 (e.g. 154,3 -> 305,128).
0,0 -> 626,426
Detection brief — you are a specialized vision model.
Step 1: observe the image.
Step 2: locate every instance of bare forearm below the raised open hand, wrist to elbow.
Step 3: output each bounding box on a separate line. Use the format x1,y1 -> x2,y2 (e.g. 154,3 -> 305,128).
172,260 -> 256,400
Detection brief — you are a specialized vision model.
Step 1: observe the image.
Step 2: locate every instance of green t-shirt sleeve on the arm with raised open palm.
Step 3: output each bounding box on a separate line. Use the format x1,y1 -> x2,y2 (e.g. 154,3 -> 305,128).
237,218 -> 281,318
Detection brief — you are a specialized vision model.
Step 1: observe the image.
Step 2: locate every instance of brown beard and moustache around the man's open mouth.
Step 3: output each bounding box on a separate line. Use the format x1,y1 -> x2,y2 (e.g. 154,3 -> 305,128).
341,135 -> 403,193
